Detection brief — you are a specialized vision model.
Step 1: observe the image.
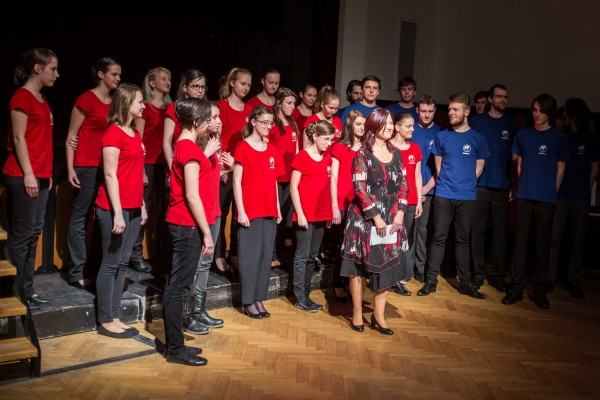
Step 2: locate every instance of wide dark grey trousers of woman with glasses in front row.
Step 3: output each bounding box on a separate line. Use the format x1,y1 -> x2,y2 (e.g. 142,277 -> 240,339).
237,217 -> 277,304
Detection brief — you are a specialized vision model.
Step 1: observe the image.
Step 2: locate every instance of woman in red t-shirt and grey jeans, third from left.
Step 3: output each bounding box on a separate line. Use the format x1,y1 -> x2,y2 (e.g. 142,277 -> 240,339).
96,83 -> 148,339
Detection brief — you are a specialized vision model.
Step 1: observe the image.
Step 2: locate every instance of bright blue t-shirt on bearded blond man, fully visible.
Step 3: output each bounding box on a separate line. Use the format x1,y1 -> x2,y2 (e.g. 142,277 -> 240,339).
431,128 -> 490,200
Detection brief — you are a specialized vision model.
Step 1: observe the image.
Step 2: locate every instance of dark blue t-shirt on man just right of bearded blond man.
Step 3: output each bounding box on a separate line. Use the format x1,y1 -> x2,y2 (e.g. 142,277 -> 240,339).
469,113 -> 519,190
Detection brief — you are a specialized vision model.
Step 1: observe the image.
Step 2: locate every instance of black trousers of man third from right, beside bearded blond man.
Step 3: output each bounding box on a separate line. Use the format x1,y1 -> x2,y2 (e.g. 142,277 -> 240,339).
471,186 -> 509,280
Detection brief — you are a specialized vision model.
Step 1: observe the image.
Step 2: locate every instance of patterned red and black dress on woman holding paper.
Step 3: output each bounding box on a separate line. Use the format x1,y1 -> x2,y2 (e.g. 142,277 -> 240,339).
341,148 -> 414,293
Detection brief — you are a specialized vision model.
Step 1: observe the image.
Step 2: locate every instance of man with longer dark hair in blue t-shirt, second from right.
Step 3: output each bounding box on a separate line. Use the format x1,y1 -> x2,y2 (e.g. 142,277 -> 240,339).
502,94 -> 569,309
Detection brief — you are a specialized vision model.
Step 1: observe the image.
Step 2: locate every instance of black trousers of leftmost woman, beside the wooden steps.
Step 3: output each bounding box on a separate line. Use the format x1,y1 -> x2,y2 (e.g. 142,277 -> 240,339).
4,175 -> 50,297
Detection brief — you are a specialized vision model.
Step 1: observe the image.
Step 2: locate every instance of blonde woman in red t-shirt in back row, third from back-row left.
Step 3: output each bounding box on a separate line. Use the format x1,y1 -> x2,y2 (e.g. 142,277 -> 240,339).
129,67 -> 172,272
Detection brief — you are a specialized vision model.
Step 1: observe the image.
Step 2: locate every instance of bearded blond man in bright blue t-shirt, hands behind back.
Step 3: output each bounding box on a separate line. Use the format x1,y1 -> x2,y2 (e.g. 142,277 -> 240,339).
417,93 -> 490,299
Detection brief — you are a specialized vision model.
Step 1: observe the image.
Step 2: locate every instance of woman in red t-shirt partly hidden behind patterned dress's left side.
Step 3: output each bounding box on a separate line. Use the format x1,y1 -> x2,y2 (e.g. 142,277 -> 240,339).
331,110 -> 366,303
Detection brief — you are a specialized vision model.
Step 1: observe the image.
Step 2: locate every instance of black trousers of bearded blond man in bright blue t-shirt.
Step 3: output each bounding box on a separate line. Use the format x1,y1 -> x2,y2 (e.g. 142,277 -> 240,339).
427,196 -> 475,284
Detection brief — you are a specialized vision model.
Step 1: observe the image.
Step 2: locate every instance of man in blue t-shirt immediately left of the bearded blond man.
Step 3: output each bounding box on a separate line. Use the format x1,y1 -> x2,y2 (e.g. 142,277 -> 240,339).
409,95 -> 440,283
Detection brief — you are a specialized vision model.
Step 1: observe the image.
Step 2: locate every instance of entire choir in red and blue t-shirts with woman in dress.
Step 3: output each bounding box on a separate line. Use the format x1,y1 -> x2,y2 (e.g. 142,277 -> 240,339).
3,48 -> 600,365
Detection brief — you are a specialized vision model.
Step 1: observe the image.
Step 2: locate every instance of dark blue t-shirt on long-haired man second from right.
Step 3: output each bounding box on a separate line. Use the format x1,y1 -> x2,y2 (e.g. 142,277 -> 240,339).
512,127 -> 569,203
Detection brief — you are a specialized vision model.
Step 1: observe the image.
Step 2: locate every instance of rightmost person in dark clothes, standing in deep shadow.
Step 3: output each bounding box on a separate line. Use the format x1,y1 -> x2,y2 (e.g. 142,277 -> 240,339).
548,98 -> 600,299
